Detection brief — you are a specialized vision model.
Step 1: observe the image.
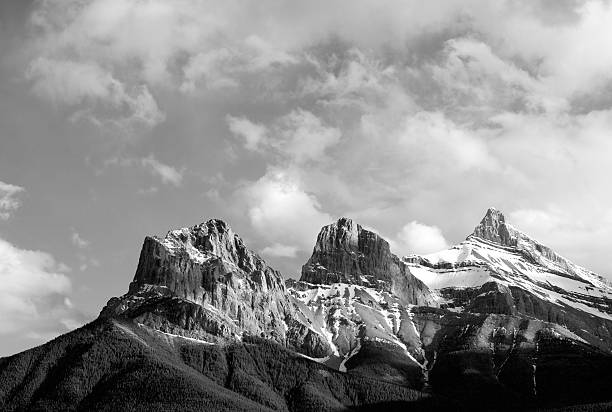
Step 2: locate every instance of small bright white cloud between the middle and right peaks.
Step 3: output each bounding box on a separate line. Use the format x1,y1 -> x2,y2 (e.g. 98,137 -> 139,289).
394,220 -> 448,255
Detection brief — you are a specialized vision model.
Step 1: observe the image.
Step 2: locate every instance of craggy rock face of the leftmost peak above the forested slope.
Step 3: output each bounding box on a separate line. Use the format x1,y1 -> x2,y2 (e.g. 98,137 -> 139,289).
102,219 -> 330,355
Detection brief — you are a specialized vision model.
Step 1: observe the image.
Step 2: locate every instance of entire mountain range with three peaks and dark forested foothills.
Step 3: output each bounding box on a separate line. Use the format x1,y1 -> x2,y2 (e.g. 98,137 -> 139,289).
0,208 -> 612,411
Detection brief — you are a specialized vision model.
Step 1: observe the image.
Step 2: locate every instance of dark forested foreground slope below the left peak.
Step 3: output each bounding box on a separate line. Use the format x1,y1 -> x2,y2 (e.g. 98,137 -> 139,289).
0,319 -> 444,411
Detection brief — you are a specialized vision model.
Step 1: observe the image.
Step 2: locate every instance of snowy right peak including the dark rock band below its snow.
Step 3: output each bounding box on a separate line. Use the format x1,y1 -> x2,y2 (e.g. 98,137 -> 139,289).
403,209 -> 612,349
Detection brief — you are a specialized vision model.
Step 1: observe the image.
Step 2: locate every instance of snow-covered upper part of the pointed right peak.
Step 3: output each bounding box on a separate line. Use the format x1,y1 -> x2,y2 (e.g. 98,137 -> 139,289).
403,208 -> 612,320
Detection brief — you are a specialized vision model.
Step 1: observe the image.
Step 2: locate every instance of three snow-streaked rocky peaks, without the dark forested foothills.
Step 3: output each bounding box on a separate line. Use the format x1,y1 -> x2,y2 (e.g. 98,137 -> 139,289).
102,209 -> 612,387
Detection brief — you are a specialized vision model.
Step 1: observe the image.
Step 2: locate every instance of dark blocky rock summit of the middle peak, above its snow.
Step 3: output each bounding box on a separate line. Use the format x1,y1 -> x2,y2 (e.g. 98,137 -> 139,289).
300,218 -> 435,305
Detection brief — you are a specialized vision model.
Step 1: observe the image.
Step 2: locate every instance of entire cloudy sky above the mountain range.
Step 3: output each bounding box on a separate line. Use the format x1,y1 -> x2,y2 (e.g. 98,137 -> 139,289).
0,0 -> 612,355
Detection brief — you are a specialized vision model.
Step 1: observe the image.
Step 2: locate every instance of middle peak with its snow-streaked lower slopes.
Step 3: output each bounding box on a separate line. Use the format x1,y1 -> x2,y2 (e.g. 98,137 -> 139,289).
287,218 -> 439,387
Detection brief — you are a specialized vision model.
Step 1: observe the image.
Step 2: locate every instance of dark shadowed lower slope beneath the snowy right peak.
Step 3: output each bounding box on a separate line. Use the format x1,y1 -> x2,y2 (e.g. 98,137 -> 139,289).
413,308 -> 610,410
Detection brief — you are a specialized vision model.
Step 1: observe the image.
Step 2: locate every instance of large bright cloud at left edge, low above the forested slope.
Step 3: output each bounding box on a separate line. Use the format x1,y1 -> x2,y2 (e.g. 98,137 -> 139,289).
0,239 -> 82,335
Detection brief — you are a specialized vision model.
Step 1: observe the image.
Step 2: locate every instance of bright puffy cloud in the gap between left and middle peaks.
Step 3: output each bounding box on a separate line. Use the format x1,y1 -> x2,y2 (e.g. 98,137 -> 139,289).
241,170 -> 332,251
